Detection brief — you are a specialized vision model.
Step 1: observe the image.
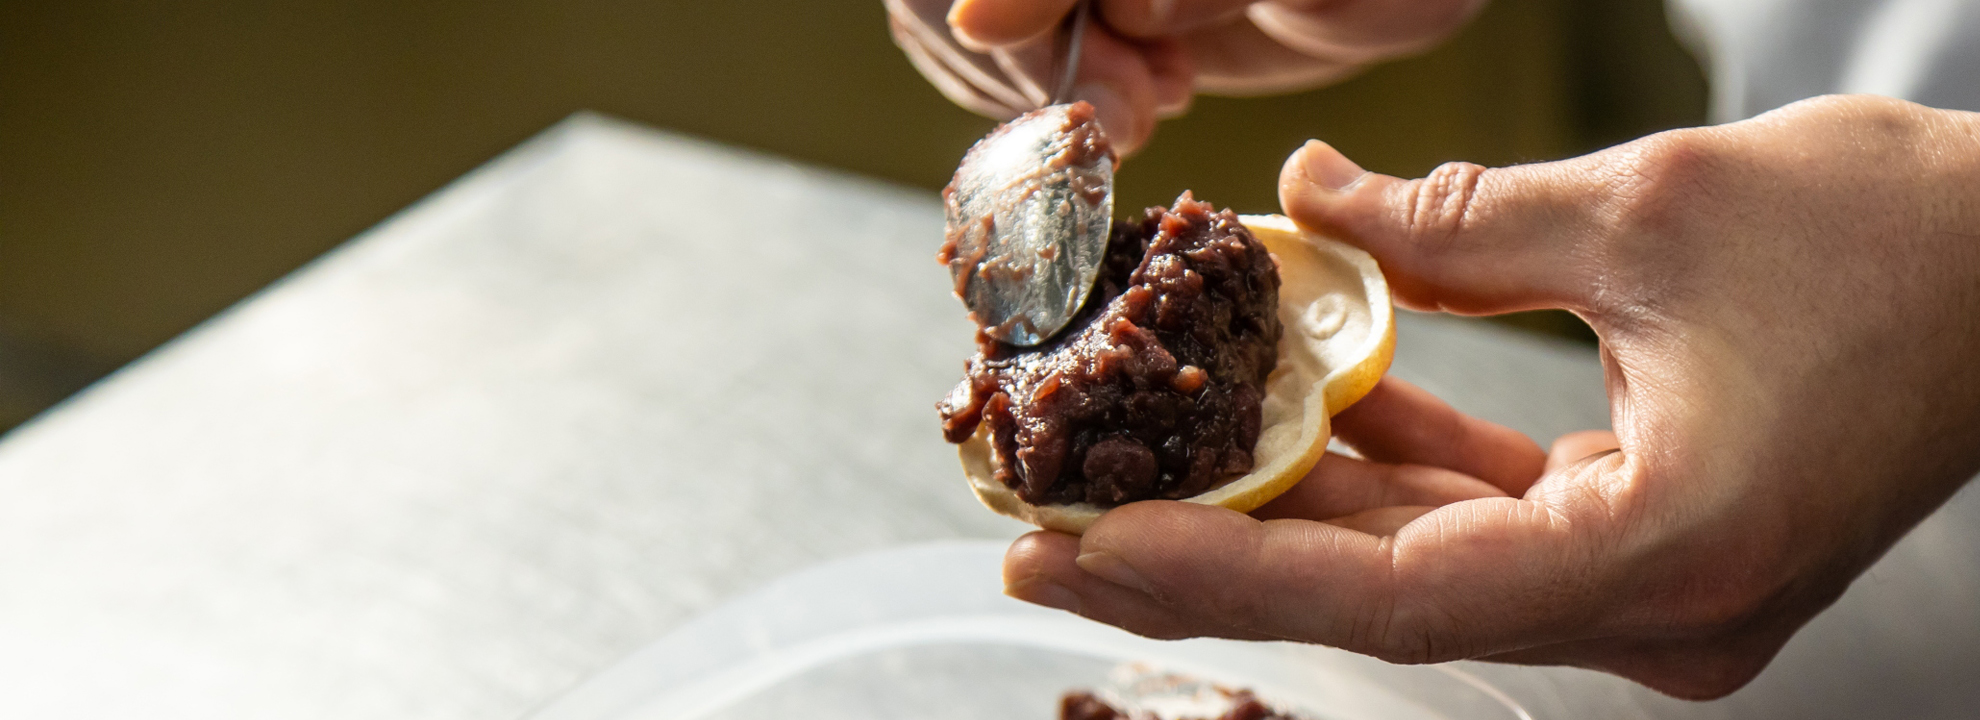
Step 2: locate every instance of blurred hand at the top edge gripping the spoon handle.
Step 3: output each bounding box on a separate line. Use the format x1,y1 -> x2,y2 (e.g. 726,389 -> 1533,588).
887,0 -> 1483,154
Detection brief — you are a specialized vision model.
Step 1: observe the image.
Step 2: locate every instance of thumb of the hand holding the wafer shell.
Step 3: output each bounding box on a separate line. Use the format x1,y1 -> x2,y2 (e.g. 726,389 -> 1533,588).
1279,140 -> 1614,315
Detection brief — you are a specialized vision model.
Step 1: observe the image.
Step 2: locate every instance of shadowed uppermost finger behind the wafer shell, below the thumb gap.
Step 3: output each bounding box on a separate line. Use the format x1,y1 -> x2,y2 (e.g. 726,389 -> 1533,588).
1333,378 -> 1546,494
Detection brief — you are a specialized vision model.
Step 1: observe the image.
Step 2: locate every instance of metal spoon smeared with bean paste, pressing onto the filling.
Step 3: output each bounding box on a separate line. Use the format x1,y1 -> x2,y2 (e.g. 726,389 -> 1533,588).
941,0 -> 1115,346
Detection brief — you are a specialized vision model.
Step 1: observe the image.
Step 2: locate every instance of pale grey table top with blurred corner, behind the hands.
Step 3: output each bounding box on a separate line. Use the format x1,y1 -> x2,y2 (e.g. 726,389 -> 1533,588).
0,115 -> 1980,718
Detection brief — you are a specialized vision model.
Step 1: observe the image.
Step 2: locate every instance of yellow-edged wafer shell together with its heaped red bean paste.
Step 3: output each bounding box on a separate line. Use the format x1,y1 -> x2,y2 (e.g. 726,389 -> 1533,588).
937,202 -> 1394,534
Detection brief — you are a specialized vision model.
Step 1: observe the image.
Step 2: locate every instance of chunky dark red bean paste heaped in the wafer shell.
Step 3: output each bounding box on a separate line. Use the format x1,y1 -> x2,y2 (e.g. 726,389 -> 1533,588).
937,192 -> 1281,506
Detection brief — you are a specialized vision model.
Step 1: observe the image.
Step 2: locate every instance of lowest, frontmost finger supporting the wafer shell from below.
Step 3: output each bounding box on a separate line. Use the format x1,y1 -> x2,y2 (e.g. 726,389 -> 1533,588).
1006,468 -> 1610,663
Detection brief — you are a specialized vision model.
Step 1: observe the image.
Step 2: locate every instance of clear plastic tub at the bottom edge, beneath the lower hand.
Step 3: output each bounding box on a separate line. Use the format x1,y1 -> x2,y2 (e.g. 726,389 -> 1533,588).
531,542 -> 1531,720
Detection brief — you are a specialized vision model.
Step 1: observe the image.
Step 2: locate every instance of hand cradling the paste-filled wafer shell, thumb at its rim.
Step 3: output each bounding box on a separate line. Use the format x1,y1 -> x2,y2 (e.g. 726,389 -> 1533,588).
1006,97 -> 1980,698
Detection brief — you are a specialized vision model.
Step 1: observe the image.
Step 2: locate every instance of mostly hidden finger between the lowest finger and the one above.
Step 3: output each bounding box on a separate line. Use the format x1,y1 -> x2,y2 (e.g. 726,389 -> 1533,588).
1251,453 -> 1505,522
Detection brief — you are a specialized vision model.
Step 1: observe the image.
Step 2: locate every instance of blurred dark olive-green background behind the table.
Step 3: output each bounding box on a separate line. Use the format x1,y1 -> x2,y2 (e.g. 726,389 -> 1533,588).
0,0 -> 1705,429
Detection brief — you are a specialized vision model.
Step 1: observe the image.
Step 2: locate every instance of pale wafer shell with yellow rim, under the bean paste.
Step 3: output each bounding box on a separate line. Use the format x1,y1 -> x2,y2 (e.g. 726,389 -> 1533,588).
960,216 -> 1396,534
